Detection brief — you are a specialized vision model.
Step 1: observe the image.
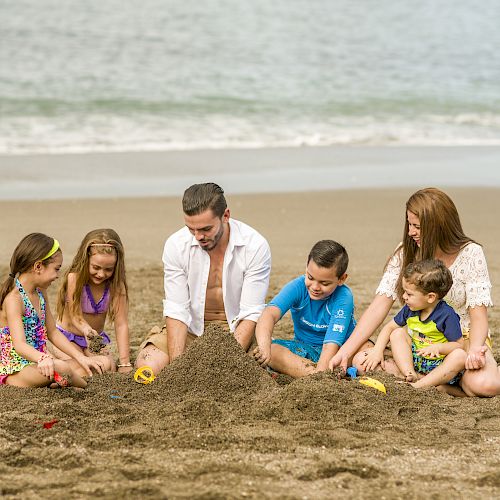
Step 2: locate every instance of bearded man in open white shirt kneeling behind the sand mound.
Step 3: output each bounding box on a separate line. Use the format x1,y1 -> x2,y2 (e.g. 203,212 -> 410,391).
135,182 -> 271,374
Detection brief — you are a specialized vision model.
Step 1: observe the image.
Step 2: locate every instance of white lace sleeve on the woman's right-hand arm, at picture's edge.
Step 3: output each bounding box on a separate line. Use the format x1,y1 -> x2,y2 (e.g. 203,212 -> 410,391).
459,243 -> 493,308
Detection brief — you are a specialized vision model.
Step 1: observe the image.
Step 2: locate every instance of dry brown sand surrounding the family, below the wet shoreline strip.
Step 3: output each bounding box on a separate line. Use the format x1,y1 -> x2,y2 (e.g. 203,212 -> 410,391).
0,189 -> 500,499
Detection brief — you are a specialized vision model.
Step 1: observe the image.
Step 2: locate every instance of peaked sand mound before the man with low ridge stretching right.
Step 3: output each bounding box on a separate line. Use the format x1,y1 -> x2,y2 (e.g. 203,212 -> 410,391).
144,325 -> 484,447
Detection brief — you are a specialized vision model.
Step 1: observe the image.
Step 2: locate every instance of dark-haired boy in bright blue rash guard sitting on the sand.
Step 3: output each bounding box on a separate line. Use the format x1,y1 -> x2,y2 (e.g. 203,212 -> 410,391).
253,240 -> 356,378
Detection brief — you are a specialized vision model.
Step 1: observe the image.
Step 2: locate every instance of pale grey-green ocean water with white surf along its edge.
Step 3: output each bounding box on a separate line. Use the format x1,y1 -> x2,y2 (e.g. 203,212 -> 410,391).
0,0 -> 500,155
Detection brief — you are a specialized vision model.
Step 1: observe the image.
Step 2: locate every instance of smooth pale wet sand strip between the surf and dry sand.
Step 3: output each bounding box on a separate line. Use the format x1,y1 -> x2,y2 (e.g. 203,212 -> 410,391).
0,145 -> 500,200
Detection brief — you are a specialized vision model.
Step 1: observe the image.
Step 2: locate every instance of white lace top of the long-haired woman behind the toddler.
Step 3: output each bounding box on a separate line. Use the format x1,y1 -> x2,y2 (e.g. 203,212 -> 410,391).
376,243 -> 493,332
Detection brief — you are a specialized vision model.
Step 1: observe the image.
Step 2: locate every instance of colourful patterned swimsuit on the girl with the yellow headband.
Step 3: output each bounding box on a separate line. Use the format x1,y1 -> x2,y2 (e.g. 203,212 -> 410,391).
0,279 -> 47,384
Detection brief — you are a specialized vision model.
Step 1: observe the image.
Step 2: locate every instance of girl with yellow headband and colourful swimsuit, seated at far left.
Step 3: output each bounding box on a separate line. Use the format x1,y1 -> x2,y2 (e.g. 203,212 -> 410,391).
0,233 -> 102,388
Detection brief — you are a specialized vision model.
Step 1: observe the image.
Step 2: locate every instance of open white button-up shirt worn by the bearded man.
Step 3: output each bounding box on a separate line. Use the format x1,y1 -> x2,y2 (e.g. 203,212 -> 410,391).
163,219 -> 271,335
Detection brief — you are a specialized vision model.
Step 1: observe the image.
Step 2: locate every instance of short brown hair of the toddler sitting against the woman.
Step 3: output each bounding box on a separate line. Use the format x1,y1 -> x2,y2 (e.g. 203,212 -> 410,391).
403,259 -> 453,299
